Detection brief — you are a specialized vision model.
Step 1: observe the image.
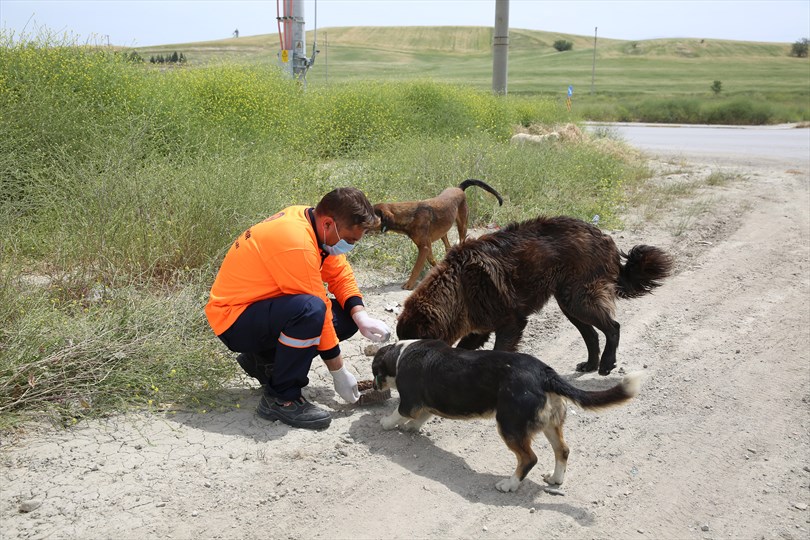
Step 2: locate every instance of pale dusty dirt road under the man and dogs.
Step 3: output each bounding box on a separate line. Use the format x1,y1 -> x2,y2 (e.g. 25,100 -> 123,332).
0,146 -> 810,539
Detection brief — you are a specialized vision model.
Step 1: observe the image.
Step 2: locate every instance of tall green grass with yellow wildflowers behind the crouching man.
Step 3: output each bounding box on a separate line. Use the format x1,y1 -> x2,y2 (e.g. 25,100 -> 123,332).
0,34 -> 646,426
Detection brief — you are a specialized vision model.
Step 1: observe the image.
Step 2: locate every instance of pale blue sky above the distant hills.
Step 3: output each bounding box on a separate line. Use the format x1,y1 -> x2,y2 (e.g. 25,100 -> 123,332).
0,0 -> 810,47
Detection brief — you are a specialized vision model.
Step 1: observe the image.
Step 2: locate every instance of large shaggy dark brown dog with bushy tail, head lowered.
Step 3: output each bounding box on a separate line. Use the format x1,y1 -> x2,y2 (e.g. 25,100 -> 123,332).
397,217 -> 673,375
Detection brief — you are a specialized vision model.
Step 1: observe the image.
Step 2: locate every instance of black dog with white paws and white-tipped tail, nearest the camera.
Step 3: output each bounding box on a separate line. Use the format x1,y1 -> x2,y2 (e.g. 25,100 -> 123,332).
371,339 -> 640,492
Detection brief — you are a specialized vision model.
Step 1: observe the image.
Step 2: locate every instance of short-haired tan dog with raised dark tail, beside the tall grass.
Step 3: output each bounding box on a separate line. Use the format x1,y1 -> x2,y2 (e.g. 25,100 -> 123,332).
374,178 -> 503,290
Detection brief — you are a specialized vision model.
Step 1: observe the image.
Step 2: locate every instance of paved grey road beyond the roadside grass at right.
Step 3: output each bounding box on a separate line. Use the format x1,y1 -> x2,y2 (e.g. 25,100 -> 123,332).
589,123 -> 810,167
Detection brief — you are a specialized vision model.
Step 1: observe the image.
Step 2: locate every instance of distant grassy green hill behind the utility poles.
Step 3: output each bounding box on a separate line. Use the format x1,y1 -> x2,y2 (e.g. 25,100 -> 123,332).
138,26 -> 810,99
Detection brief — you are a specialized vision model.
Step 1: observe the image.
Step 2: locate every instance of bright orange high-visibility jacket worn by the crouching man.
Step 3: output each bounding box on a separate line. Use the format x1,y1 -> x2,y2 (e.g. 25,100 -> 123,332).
205,206 -> 362,351
